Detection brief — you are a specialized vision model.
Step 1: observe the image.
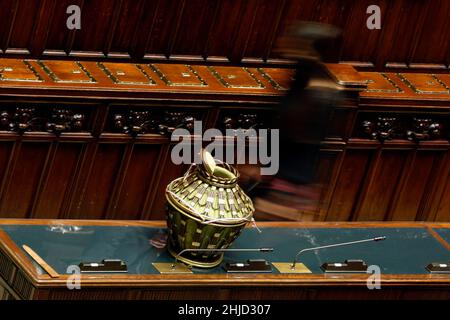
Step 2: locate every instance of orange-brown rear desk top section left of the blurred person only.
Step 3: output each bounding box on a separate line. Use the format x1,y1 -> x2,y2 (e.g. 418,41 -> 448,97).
0,59 -> 293,99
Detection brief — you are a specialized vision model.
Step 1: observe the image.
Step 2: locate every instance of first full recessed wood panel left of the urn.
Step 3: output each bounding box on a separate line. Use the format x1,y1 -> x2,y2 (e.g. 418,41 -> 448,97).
113,144 -> 161,219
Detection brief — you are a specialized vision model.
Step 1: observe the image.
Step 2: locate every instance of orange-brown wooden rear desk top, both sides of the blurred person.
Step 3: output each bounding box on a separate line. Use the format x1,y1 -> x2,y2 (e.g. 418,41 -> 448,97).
0,58 -> 450,102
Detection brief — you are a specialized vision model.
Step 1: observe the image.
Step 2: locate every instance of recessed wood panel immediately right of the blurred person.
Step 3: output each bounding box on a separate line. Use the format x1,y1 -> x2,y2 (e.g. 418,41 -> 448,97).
326,149 -> 372,221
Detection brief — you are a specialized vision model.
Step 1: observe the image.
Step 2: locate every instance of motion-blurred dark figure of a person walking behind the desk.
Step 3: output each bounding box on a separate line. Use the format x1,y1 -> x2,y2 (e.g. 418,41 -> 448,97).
242,22 -> 342,221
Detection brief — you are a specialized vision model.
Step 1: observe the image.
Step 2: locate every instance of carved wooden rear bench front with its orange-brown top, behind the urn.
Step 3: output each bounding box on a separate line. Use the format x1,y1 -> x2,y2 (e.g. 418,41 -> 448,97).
0,59 -> 450,221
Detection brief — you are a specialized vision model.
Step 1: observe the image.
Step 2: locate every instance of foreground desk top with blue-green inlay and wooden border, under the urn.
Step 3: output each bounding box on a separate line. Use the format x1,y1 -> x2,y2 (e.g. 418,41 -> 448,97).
0,219 -> 450,288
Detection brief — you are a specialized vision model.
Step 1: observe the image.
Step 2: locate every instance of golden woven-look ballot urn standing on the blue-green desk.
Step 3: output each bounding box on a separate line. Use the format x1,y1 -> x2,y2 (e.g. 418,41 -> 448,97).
166,150 -> 255,268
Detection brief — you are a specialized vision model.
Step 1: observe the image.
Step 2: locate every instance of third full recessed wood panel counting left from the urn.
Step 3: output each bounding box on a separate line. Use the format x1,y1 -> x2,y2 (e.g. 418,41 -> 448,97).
33,143 -> 83,219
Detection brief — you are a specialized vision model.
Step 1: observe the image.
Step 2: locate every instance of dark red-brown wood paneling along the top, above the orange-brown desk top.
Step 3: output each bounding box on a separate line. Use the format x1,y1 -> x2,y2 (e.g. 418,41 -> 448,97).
0,0 -> 450,69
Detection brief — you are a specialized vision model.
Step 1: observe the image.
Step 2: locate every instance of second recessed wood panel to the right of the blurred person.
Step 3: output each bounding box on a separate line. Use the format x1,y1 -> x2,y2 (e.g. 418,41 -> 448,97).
355,150 -> 408,221
